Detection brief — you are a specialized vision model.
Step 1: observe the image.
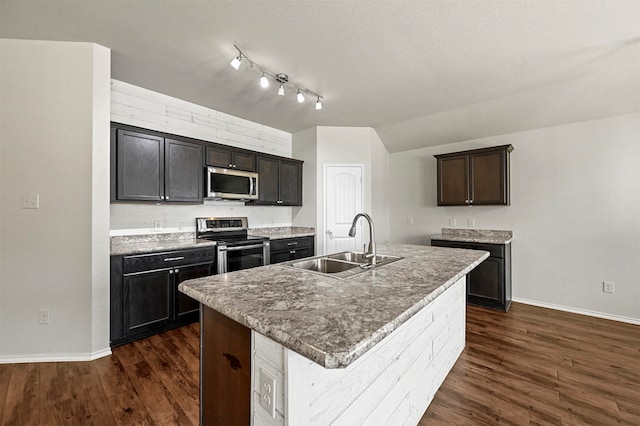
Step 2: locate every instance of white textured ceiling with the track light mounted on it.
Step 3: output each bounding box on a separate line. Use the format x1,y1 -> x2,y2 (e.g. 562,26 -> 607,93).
0,0 -> 640,152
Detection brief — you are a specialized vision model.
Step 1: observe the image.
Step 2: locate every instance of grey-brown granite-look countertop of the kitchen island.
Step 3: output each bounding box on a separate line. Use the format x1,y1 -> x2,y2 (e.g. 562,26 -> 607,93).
179,244 -> 489,368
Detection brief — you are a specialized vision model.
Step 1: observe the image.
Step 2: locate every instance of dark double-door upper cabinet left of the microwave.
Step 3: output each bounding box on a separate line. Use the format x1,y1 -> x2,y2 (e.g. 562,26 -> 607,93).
111,128 -> 203,203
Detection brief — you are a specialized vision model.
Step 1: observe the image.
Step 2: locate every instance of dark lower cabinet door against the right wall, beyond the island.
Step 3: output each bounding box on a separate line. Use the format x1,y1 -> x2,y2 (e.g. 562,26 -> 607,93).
467,257 -> 504,306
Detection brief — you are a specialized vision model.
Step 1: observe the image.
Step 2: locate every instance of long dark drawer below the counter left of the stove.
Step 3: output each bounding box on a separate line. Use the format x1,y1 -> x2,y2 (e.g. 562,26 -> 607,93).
122,248 -> 215,274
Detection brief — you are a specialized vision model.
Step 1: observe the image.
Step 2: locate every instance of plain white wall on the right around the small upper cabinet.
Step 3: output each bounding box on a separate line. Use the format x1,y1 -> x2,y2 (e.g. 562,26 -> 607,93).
389,114 -> 640,322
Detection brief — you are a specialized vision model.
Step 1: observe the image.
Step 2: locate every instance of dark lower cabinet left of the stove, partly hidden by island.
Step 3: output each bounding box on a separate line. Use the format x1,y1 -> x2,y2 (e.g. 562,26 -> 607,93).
110,247 -> 216,346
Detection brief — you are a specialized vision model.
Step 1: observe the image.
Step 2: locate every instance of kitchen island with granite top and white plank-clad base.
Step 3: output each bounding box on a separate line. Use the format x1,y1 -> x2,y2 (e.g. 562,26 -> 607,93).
180,245 -> 488,425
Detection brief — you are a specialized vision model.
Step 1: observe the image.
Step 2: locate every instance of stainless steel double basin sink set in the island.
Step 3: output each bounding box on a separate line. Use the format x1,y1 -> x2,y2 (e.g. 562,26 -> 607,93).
286,251 -> 402,278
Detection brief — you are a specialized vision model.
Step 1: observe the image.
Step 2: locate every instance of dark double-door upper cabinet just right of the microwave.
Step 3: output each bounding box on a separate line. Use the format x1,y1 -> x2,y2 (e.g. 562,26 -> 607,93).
254,155 -> 302,206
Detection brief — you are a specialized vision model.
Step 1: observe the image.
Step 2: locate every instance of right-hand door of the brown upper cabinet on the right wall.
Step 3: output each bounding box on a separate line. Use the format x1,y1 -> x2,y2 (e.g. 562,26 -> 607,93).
469,150 -> 509,205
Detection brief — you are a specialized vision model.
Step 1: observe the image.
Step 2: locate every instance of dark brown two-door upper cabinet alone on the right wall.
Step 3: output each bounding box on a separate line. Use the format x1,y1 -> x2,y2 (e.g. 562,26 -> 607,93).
434,145 -> 513,206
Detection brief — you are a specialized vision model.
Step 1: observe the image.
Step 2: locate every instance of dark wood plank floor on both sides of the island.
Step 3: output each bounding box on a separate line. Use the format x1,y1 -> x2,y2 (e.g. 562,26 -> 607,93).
0,303 -> 640,426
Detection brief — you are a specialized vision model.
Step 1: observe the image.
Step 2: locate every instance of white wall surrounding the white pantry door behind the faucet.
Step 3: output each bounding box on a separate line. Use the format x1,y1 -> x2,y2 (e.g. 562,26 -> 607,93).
293,126 -> 389,253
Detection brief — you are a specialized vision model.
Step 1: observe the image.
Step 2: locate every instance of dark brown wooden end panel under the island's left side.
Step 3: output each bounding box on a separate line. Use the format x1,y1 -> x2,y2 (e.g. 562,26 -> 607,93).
200,305 -> 251,426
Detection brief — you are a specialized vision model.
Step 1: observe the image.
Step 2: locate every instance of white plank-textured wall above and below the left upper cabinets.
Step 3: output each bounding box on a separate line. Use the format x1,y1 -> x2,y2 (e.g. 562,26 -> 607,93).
111,80 -> 296,235
